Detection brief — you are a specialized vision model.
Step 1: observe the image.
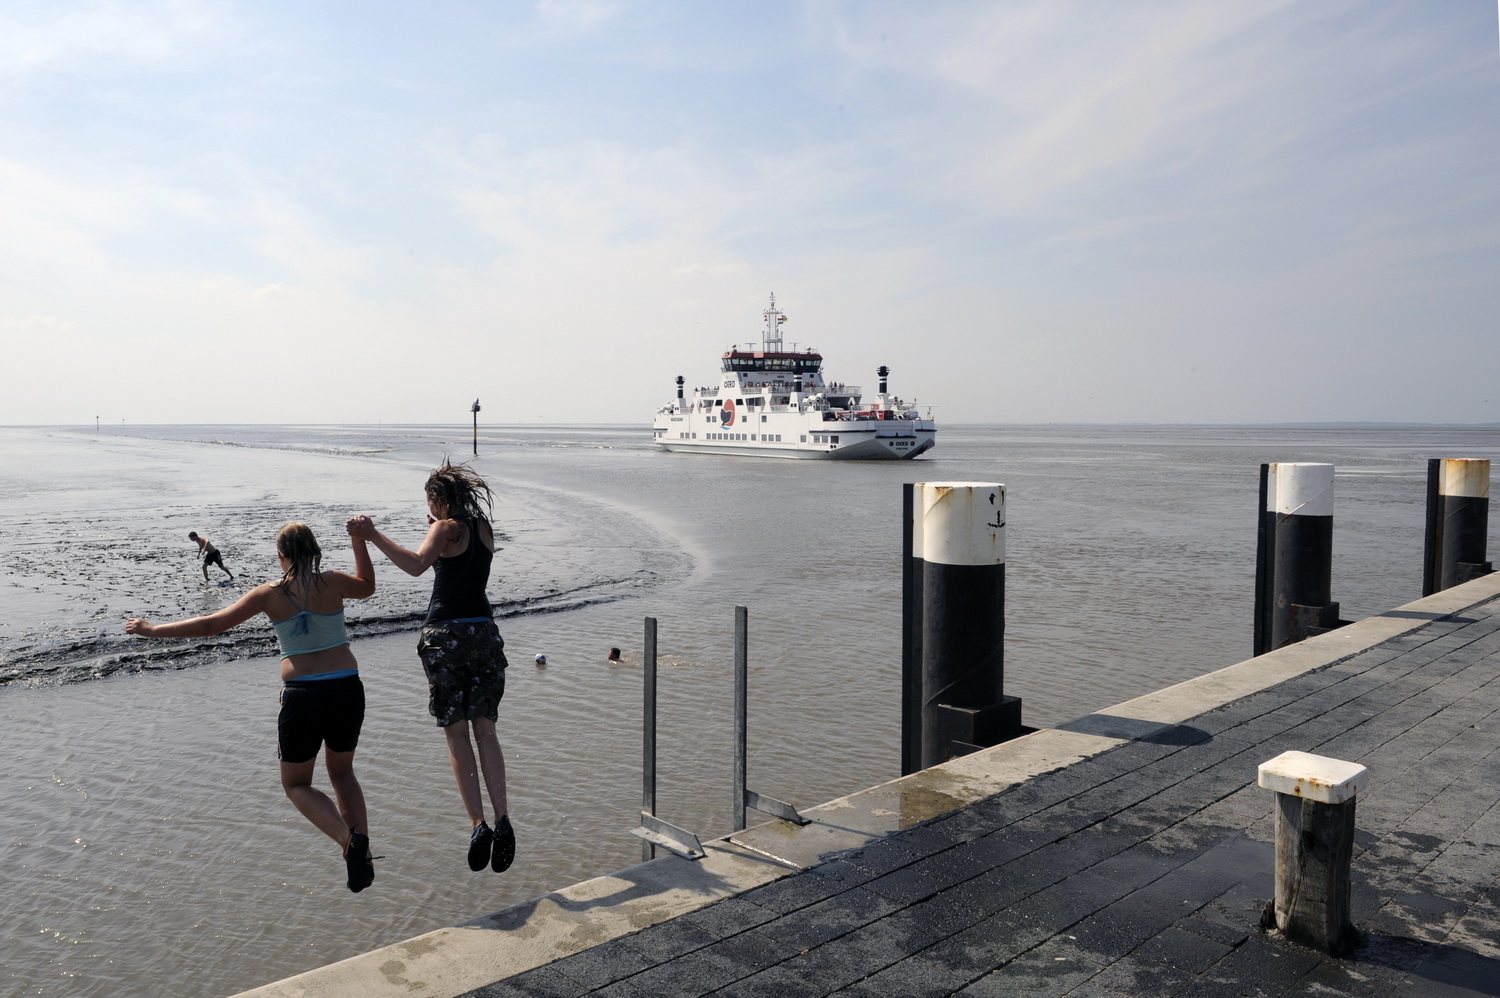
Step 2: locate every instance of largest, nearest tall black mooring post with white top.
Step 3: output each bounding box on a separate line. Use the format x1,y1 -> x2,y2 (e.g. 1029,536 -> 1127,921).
914,482 -> 1022,768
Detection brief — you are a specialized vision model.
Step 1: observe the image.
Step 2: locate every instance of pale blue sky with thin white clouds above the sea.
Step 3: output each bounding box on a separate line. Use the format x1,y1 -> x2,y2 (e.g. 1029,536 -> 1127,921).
0,0 -> 1500,425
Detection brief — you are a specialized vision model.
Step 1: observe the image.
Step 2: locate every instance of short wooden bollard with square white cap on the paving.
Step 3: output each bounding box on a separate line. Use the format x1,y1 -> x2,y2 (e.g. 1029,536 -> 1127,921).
1257,752 -> 1368,954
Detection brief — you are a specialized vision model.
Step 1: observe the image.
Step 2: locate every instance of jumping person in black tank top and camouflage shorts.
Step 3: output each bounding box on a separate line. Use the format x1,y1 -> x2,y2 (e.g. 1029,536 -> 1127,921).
348,461 -> 516,873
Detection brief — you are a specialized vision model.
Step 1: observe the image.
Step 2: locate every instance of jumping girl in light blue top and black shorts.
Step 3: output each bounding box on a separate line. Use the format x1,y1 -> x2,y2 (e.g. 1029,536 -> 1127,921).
125,524 -> 375,893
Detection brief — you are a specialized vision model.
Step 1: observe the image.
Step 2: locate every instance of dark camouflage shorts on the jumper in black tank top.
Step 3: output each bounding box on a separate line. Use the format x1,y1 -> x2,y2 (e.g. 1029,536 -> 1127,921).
417,620 -> 507,728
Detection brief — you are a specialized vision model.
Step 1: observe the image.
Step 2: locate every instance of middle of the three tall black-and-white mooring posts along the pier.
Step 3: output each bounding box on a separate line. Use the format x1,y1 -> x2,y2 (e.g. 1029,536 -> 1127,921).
1256,462 -> 1343,654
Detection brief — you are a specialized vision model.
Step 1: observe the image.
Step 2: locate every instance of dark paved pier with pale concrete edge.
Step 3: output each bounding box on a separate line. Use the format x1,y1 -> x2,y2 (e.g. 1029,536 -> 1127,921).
237,575 -> 1500,998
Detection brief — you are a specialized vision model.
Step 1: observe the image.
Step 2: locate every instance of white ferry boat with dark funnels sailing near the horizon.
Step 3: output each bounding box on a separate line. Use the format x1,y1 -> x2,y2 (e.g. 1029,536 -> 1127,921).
653,294 -> 938,461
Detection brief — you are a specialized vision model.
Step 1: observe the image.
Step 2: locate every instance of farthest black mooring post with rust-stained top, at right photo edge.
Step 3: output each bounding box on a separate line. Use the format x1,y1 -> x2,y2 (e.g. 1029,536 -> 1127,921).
1422,458 -> 1494,596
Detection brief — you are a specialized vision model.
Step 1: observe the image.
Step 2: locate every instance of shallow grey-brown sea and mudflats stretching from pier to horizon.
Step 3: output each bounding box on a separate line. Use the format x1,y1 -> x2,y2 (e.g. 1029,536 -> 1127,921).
0,426 -> 1500,996
